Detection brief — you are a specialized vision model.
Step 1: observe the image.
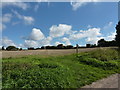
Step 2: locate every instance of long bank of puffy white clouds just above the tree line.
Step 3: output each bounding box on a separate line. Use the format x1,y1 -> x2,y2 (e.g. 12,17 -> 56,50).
3,20 -> 116,47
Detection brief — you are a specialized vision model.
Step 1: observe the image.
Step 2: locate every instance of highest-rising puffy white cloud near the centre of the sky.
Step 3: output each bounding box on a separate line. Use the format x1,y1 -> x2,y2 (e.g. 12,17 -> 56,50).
50,24 -> 72,37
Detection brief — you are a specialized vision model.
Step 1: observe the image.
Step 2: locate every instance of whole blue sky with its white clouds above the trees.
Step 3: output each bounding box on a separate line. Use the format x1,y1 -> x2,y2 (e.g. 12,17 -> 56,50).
0,2 -> 118,48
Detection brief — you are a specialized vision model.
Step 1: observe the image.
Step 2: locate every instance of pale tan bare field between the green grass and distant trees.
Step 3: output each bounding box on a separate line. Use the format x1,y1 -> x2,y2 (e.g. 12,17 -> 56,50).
2,48 -> 97,58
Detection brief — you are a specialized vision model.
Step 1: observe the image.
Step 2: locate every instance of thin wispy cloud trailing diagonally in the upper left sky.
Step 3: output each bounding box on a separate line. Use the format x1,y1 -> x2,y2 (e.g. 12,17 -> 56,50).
12,10 -> 35,25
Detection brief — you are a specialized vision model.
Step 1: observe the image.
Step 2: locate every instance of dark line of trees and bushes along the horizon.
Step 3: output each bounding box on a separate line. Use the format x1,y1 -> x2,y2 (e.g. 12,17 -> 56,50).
2,21 -> 120,51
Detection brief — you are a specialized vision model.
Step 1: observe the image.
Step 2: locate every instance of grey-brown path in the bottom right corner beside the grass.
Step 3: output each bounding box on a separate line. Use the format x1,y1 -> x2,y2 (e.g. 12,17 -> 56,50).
82,74 -> 120,88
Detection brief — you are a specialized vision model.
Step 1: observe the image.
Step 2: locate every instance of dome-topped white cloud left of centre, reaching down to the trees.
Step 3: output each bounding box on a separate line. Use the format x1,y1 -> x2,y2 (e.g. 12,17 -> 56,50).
23,28 -> 52,47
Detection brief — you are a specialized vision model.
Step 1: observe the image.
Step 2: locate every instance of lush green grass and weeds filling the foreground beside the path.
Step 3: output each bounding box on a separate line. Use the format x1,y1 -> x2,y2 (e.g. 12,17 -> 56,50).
2,49 -> 120,88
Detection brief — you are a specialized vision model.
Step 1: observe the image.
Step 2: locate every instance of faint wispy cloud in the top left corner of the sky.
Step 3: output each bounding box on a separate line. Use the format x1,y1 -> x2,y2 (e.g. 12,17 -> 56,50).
2,0 -> 29,10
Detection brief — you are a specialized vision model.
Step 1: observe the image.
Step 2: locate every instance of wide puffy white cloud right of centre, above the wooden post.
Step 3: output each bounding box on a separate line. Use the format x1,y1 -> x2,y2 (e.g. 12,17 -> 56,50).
69,28 -> 102,44
